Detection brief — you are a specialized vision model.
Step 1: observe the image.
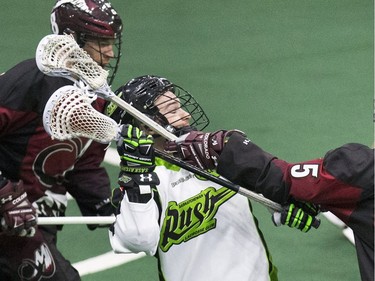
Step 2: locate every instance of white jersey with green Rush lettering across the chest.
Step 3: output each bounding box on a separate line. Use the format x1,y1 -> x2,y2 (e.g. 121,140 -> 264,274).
110,159 -> 277,281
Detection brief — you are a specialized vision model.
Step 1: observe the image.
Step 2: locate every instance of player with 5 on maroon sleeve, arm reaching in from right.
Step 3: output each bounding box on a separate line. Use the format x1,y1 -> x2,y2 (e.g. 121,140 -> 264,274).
166,131 -> 374,281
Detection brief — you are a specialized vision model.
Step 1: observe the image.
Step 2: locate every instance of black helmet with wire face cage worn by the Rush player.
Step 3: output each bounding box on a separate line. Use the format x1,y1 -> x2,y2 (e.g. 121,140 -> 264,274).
106,75 -> 209,135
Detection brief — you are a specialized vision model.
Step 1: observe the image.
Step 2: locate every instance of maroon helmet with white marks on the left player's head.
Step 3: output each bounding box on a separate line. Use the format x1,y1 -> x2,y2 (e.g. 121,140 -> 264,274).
51,0 -> 122,85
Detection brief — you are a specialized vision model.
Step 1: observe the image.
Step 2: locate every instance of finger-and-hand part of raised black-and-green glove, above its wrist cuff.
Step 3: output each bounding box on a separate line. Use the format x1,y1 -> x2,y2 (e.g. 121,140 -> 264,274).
117,125 -> 155,174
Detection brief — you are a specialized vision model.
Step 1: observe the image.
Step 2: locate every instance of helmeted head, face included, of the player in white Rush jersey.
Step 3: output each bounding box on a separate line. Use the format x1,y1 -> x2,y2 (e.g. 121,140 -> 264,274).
107,75 -> 209,135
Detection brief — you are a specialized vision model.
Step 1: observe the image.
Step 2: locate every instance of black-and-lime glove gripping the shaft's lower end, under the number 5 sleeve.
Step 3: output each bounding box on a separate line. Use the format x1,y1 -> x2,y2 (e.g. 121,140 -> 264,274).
272,202 -> 320,232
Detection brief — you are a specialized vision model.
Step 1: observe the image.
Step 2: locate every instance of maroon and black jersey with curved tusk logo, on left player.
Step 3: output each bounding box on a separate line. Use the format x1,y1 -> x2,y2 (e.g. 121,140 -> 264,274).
0,59 -> 110,212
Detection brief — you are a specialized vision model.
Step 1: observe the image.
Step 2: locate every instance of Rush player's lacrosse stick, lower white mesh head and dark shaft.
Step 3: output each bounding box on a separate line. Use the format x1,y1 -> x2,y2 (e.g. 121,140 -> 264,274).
43,86 -> 282,211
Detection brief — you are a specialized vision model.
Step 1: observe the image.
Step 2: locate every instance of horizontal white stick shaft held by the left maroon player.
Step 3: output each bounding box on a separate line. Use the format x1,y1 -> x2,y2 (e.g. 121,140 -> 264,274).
38,216 -> 116,225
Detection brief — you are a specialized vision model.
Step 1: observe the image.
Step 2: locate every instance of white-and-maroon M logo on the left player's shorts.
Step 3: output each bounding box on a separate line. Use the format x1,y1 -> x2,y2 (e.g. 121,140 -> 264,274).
18,243 -> 56,281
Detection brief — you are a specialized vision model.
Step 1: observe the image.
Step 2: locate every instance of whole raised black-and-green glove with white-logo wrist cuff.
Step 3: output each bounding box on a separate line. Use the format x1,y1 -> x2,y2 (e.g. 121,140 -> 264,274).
117,125 -> 160,203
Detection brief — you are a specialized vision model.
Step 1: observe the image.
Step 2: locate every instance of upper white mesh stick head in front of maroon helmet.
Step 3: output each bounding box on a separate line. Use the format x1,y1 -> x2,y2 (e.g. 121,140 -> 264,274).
35,34 -> 108,90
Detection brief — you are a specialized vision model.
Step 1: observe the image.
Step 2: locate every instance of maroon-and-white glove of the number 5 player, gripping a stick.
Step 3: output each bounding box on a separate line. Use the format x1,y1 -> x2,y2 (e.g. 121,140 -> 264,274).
164,130 -> 245,170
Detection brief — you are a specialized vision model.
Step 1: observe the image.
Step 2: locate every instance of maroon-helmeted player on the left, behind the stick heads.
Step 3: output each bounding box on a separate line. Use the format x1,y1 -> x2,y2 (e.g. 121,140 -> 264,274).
0,0 -> 122,281
